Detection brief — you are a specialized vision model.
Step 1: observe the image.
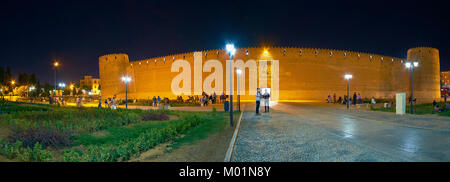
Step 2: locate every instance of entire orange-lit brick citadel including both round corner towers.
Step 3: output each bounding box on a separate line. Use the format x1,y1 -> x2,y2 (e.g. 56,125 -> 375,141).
99,47 -> 440,102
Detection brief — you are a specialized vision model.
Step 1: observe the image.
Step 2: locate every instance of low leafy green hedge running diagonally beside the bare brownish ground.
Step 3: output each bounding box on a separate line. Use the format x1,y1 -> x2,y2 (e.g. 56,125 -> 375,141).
63,115 -> 205,162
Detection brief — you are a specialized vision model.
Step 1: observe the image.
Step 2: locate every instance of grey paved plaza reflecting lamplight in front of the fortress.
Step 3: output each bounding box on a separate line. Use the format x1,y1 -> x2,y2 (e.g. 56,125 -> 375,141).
232,103 -> 450,162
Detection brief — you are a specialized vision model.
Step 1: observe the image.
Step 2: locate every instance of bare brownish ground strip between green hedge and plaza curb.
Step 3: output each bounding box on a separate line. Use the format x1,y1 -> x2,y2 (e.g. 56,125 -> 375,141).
138,124 -> 234,162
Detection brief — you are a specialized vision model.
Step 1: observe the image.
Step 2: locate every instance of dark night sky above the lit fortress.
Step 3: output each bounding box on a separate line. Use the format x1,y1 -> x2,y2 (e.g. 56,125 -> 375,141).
0,0 -> 450,83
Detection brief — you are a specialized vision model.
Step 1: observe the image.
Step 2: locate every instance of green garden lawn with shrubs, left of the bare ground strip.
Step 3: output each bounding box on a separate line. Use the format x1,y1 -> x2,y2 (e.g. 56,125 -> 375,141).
0,102 -> 232,161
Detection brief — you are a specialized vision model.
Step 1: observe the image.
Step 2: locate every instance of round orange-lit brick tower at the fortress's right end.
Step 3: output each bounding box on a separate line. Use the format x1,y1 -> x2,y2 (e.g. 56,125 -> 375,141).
407,47 -> 441,103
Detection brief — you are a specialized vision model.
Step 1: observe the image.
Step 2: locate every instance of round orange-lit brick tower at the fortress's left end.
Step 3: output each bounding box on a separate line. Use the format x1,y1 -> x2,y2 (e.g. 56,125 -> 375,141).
98,54 -> 129,100
